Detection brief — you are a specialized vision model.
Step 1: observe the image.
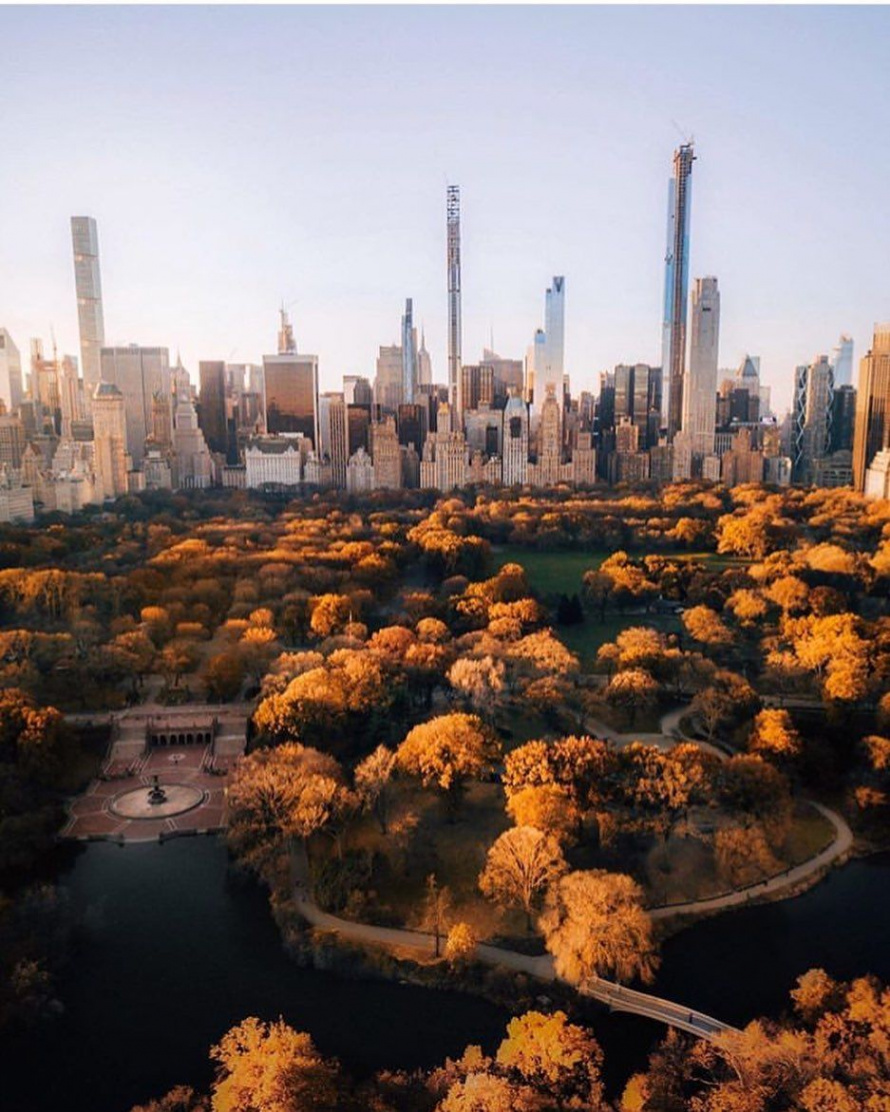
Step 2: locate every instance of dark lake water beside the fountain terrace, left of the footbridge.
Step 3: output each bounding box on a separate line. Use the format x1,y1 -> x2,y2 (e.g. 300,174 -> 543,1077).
0,837 -> 508,1112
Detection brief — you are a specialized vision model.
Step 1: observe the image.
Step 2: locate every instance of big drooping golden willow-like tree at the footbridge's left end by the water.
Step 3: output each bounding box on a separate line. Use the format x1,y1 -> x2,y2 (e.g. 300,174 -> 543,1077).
540,870 -> 657,984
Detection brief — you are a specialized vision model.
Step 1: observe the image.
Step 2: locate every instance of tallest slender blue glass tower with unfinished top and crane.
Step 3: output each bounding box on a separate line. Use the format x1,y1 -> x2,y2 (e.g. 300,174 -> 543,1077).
662,142 -> 695,438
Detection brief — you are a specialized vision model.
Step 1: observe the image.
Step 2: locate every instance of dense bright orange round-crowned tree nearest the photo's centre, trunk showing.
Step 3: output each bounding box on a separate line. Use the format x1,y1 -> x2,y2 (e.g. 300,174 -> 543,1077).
396,714 -> 500,816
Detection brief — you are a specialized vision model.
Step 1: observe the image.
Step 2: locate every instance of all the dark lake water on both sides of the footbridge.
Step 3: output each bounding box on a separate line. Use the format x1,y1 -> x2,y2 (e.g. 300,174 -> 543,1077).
0,838 -> 890,1112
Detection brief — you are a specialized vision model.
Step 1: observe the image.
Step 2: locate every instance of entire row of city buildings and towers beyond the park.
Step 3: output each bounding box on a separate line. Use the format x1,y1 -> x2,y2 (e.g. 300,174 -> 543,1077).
0,143 -> 890,519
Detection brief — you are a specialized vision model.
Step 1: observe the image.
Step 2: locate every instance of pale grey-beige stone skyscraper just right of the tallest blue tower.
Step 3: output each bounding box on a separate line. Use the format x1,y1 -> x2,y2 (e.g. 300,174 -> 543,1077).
682,278 -> 720,456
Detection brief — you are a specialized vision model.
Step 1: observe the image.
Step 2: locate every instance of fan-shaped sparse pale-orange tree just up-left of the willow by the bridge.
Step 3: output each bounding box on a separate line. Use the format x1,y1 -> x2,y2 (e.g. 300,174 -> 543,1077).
479,826 -> 567,931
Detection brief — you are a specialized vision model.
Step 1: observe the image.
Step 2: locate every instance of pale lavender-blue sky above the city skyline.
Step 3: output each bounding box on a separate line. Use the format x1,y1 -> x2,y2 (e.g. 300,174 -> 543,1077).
0,6 -> 890,408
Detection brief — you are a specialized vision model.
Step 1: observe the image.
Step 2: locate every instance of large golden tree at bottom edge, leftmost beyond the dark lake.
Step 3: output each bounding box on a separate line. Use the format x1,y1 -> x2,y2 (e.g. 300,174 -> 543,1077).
210,1019 -> 340,1112
